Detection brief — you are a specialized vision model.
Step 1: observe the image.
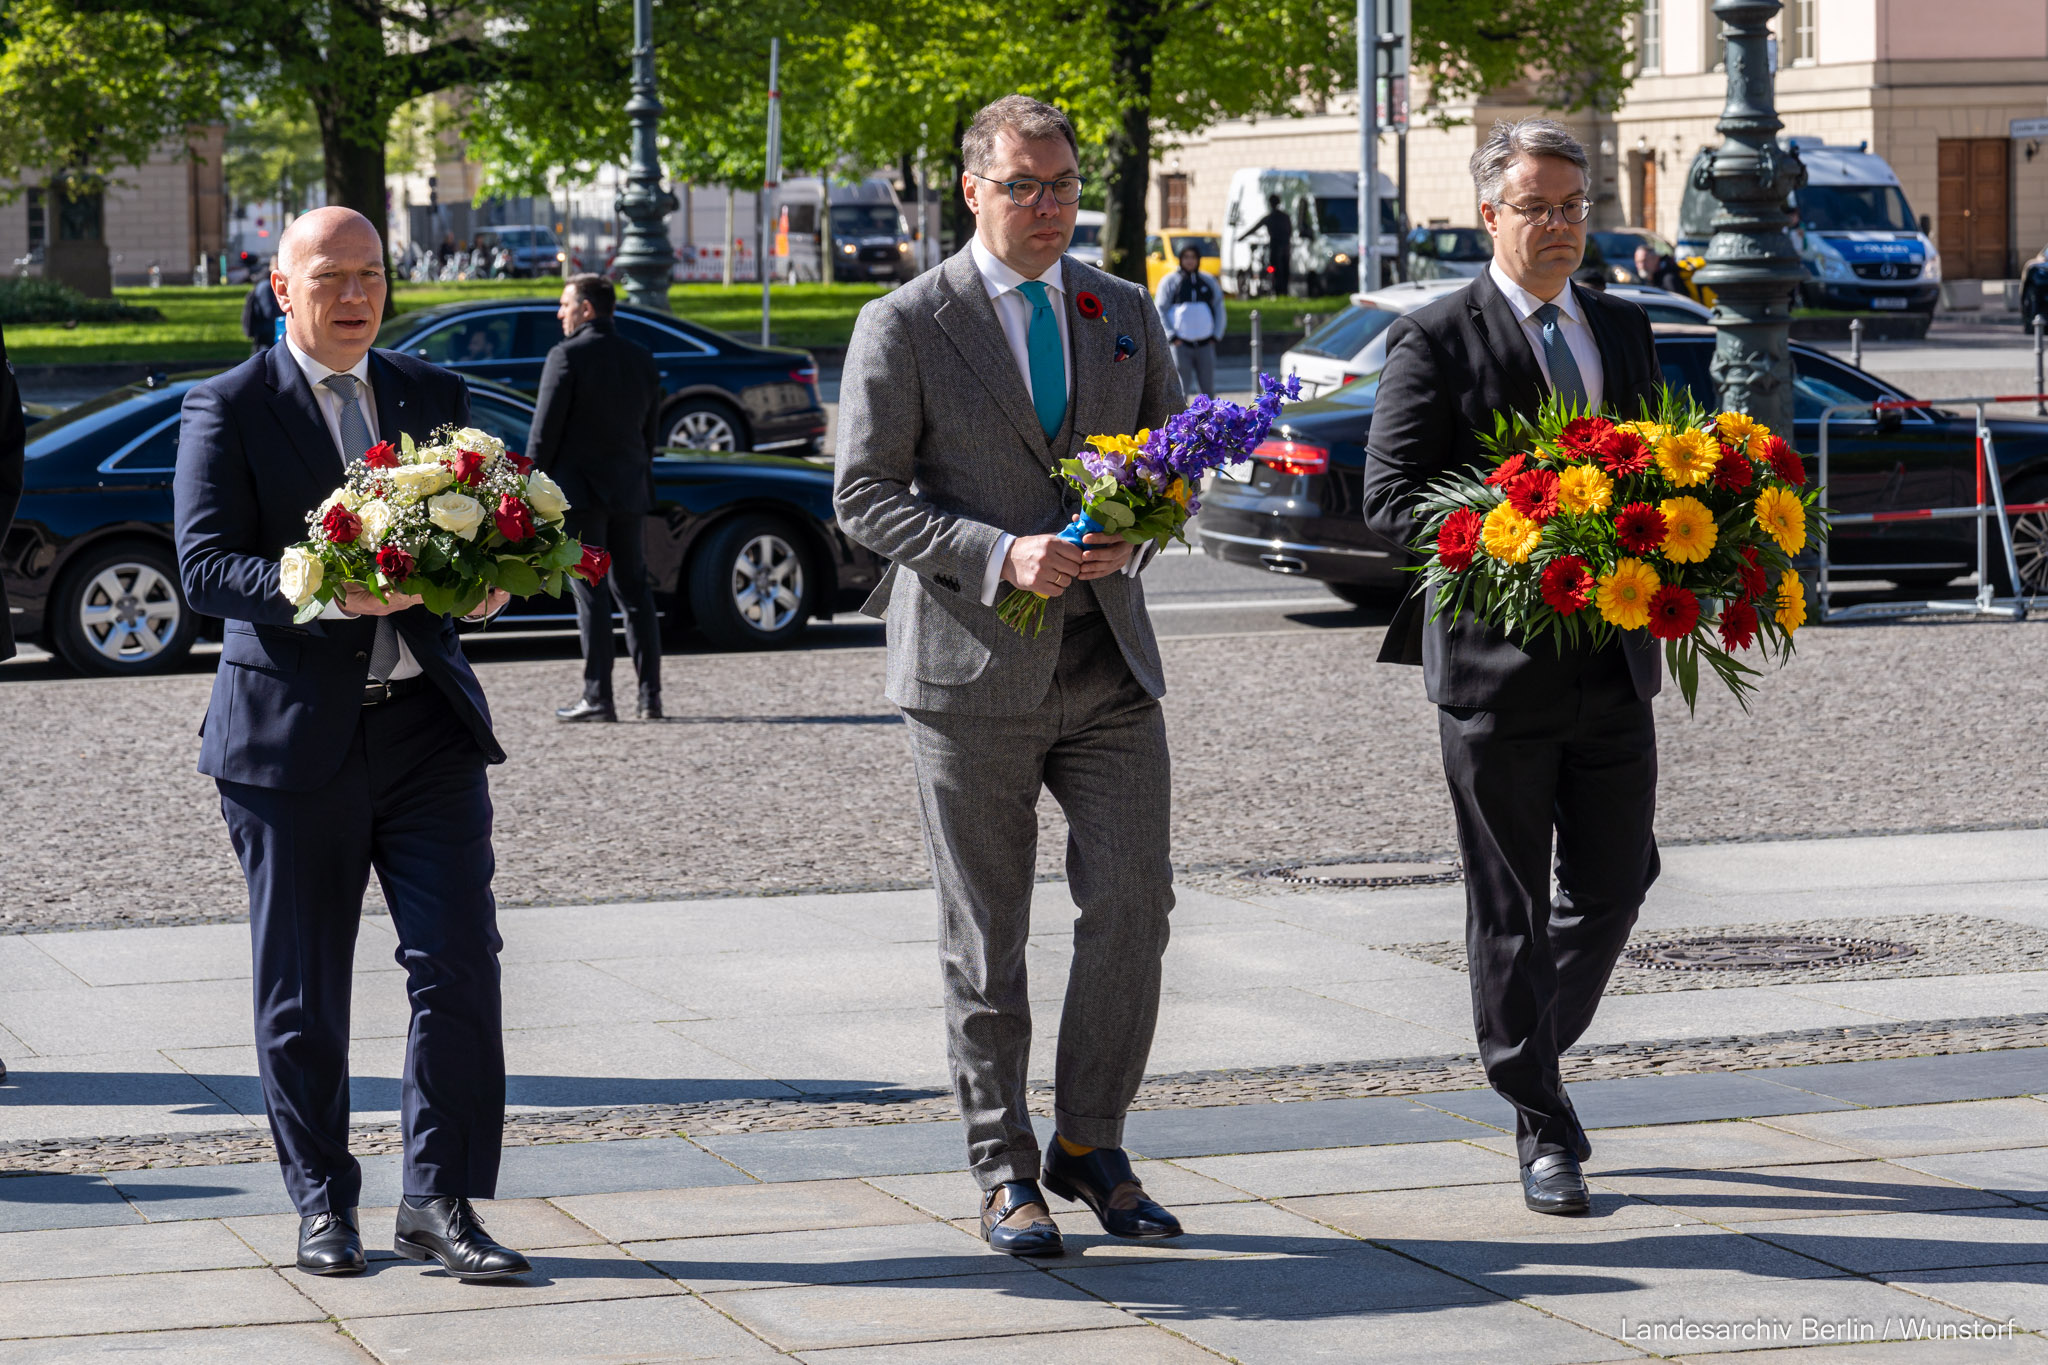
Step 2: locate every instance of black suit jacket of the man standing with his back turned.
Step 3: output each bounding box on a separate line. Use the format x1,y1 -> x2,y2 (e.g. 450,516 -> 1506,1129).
526,317 -> 662,516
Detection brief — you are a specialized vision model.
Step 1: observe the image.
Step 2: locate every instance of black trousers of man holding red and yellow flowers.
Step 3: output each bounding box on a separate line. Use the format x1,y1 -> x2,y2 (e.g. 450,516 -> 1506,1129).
1438,655 -> 1659,1164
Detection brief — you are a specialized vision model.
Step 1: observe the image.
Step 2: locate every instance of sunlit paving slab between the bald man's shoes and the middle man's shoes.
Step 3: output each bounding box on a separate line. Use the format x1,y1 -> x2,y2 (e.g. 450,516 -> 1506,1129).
551,1181 -> 926,1242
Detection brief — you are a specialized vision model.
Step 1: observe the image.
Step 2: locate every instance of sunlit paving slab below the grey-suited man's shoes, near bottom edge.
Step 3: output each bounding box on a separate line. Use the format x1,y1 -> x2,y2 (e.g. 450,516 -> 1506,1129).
707,1265 -> 1130,1353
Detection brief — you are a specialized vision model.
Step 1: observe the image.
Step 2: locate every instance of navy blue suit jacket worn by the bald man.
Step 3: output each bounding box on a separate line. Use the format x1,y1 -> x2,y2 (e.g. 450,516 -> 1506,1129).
174,342 -> 504,792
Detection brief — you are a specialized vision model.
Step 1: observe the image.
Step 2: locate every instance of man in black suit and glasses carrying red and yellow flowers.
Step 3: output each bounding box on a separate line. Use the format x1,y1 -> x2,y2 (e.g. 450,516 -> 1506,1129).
1364,119 -> 1661,1214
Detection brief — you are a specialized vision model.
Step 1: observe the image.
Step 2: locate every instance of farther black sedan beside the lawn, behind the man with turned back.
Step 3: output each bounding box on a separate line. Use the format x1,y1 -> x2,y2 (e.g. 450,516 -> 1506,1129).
377,299 -> 825,454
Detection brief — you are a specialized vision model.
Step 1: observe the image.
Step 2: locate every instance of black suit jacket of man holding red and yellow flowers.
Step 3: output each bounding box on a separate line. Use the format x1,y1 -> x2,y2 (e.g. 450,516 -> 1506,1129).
1364,272 -> 1663,710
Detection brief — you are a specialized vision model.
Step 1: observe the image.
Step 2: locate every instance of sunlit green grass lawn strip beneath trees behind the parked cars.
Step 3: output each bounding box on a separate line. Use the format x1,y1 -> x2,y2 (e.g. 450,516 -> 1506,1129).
6,280 -> 1350,366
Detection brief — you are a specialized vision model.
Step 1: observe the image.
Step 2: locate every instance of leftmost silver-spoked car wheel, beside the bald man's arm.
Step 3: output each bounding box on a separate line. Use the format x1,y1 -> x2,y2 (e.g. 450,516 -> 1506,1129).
49,540 -> 199,677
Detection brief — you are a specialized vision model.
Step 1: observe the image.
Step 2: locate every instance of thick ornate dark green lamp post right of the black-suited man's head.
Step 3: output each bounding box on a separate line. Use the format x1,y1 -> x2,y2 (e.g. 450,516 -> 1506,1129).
1692,0 -> 1806,438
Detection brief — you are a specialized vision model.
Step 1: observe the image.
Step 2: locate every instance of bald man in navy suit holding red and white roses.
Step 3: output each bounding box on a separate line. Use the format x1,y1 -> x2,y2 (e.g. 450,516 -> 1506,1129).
174,207 -> 528,1279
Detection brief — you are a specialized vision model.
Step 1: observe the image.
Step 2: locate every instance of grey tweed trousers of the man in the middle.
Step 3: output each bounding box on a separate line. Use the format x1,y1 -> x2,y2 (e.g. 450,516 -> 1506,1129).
903,614 -> 1174,1189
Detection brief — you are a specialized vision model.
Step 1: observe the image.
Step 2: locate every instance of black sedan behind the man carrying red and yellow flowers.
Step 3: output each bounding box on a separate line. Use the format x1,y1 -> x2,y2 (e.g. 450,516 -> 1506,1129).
1198,325 -> 2048,604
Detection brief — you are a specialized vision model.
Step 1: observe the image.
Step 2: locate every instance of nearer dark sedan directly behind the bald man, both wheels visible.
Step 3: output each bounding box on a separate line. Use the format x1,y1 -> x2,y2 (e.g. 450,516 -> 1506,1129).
0,375 -> 883,675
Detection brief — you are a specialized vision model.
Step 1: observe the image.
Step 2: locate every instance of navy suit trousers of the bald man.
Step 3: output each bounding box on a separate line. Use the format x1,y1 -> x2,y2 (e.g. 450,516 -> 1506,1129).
219,688 -> 506,1214
